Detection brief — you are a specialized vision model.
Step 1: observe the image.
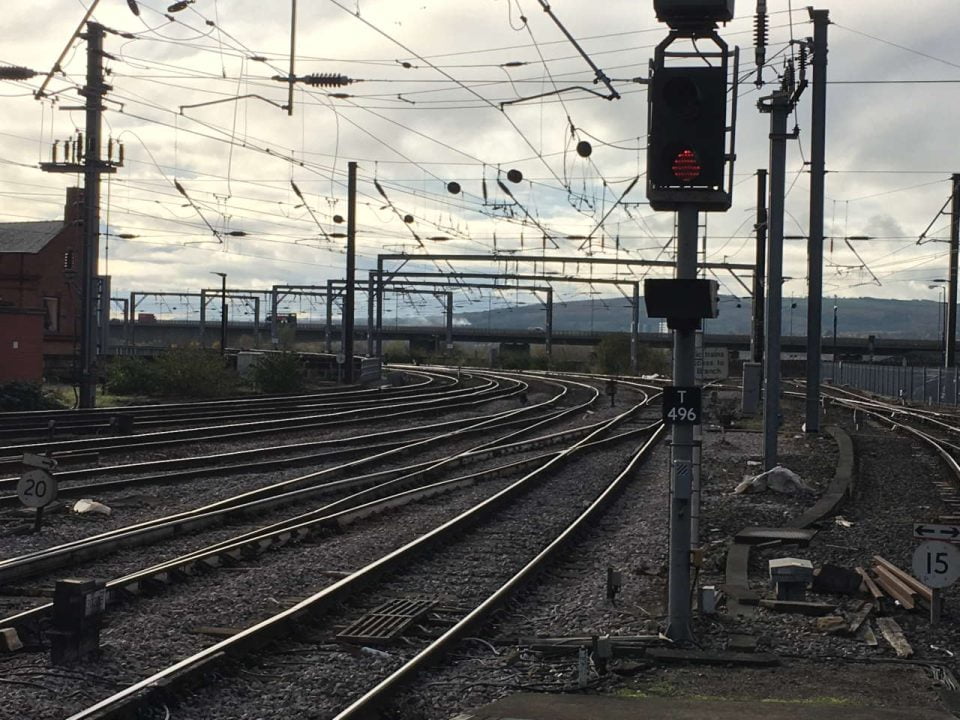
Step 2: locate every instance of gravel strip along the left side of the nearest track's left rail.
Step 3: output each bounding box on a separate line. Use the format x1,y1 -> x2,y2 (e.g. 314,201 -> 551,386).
0,466 -> 528,720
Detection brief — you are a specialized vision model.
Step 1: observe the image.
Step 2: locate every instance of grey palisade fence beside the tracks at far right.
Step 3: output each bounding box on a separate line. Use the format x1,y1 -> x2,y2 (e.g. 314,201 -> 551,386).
820,360 -> 960,406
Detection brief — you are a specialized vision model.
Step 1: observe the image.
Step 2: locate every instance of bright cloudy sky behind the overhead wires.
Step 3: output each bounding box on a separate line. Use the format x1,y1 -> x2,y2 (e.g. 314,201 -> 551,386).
0,0 -> 960,320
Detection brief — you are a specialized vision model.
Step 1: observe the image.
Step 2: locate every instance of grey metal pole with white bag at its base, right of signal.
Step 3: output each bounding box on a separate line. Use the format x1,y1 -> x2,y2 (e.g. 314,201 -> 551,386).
763,90 -> 793,470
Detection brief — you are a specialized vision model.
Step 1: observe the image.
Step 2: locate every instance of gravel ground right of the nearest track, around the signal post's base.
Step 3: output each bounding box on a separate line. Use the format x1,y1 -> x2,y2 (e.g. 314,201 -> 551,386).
388,390 -> 960,720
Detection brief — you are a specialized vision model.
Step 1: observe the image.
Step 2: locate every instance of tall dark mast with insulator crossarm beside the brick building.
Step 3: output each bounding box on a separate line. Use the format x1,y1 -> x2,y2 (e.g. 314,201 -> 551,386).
79,22 -> 109,408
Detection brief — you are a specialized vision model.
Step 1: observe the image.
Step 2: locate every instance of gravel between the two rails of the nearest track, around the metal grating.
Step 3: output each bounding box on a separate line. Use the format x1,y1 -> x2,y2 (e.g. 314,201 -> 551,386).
137,434 -> 652,720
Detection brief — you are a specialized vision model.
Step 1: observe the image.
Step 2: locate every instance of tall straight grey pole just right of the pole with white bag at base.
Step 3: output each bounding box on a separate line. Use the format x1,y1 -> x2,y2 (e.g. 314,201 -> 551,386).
804,8 -> 830,433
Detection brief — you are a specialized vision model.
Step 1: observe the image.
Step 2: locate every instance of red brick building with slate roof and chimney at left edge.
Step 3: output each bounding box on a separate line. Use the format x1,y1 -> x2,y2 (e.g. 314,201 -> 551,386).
0,188 -> 83,382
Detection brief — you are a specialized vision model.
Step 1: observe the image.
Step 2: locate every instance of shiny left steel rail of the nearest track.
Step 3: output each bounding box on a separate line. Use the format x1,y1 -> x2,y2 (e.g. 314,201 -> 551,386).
68,390 -> 648,720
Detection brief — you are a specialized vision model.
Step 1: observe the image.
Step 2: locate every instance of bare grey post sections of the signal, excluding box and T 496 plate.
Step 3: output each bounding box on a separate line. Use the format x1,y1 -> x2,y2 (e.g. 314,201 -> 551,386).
667,205 -> 699,641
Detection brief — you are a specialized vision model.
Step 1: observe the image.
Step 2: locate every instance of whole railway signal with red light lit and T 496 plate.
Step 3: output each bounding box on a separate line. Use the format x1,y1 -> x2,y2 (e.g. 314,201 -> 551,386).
644,0 -> 737,642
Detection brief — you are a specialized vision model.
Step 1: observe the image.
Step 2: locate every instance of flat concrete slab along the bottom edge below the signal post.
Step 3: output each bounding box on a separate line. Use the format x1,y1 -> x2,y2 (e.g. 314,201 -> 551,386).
458,693 -> 955,720
